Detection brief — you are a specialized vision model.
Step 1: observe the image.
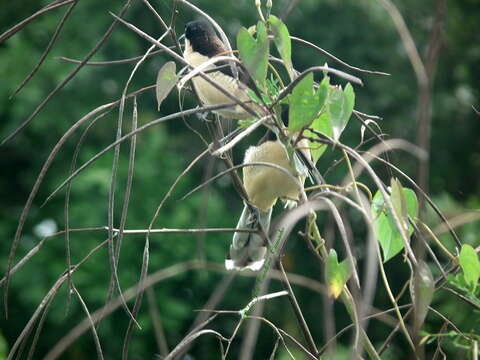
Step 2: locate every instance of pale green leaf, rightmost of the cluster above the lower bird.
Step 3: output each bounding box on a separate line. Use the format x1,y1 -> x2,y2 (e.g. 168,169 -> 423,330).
328,83 -> 355,140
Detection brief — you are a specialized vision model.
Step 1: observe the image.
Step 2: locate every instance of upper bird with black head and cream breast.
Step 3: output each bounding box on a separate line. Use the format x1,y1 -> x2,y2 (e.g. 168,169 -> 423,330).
183,20 -> 262,119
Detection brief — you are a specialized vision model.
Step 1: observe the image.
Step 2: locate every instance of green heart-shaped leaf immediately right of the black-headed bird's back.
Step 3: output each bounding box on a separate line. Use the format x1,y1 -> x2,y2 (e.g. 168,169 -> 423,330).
237,21 -> 269,89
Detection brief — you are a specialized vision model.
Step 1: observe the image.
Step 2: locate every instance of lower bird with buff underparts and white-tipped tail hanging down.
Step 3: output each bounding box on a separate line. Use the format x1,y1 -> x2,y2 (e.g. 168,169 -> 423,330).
225,139 -> 310,270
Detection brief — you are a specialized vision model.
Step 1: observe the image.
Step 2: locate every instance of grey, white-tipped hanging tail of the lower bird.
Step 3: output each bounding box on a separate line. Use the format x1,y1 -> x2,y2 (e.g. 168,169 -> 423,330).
225,205 -> 272,271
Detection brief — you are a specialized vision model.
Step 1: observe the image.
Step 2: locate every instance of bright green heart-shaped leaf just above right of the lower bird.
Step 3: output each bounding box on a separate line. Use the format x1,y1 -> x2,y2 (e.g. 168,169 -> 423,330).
288,73 -> 326,132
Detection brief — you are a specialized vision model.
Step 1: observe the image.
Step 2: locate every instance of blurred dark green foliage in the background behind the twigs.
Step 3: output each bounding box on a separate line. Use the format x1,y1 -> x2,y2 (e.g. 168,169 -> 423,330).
0,0 -> 480,359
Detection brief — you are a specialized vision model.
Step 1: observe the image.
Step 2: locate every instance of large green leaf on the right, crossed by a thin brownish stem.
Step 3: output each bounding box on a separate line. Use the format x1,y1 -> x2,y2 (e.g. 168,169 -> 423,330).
371,188 -> 418,262
